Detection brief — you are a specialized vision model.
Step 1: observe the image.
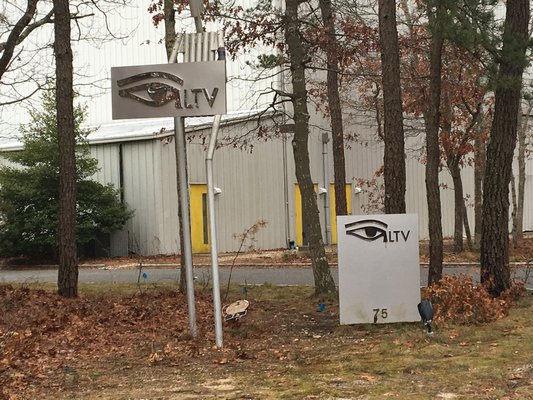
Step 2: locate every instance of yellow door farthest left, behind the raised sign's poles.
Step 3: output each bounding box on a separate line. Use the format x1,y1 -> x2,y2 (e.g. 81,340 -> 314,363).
190,185 -> 210,253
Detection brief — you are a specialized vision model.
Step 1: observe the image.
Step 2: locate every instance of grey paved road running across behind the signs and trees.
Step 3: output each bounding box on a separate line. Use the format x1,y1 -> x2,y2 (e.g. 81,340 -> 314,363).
0,266 -> 533,289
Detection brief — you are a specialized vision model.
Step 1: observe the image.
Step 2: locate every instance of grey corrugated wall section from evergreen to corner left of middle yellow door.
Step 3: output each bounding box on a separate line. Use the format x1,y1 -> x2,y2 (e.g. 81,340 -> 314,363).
92,117 -> 286,255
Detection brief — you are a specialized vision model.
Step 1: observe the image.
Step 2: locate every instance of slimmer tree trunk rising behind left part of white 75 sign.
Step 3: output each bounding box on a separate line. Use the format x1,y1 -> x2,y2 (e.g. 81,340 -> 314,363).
319,0 -> 348,215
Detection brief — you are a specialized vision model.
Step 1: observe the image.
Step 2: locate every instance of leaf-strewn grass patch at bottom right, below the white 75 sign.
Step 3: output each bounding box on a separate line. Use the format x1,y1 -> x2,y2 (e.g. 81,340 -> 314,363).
219,292 -> 533,399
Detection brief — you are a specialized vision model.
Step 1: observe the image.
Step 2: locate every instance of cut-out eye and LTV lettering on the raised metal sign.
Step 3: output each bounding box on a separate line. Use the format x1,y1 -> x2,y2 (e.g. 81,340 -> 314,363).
117,71 -> 218,110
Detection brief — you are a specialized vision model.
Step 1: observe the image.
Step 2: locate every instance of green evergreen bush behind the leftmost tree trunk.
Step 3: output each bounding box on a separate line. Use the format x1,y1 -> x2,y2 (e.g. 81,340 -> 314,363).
0,91 -> 132,257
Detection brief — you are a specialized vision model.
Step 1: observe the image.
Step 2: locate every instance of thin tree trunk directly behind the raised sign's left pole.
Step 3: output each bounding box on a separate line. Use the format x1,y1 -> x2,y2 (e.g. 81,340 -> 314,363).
163,0 -> 189,293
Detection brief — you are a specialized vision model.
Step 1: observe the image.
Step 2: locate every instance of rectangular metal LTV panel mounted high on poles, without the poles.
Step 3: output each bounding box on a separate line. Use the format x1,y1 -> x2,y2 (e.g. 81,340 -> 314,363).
111,61 -> 226,119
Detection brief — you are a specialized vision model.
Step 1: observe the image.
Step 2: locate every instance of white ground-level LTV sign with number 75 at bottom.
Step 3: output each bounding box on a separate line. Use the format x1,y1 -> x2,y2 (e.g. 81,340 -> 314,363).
337,214 -> 420,324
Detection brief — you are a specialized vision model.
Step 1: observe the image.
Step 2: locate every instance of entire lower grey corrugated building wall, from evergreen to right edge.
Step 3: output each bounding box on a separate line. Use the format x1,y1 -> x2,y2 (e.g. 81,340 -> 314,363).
85,111 -> 533,255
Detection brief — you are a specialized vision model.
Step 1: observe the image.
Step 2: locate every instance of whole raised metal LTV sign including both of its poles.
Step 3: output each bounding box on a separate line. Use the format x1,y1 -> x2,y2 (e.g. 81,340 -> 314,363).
111,21 -> 226,347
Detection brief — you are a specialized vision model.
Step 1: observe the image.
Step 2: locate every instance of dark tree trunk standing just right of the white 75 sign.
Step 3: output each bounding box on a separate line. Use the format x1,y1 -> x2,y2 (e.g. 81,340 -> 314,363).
424,4 -> 444,286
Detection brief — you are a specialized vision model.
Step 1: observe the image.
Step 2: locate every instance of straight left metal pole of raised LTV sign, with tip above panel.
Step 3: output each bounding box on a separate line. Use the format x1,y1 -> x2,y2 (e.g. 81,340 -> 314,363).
168,36 -> 196,337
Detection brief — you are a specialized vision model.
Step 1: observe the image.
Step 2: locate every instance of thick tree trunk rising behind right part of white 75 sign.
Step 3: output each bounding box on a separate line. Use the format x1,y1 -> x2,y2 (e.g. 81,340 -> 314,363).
378,0 -> 406,214
